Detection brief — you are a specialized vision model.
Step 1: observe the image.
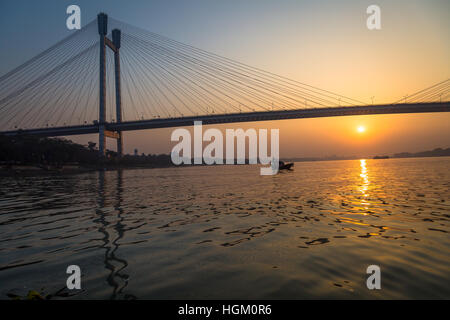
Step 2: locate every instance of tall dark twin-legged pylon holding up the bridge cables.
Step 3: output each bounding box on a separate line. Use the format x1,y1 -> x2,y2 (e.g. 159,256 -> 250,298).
97,13 -> 123,157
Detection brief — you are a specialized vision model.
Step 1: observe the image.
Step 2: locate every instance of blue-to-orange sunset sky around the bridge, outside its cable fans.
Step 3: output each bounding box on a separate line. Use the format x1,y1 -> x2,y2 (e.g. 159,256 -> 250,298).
0,0 -> 450,157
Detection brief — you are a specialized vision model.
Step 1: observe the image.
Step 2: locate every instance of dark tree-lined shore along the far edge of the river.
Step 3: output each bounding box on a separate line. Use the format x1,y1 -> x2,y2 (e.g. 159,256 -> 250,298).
0,135 -> 450,177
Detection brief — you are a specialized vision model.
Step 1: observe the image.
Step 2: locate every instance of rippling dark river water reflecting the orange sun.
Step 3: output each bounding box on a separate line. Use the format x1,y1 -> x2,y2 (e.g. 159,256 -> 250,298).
0,158 -> 450,299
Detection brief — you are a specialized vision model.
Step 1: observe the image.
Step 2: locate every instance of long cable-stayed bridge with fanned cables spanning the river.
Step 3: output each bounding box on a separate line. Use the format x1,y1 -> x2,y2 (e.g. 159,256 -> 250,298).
0,14 -> 450,155
